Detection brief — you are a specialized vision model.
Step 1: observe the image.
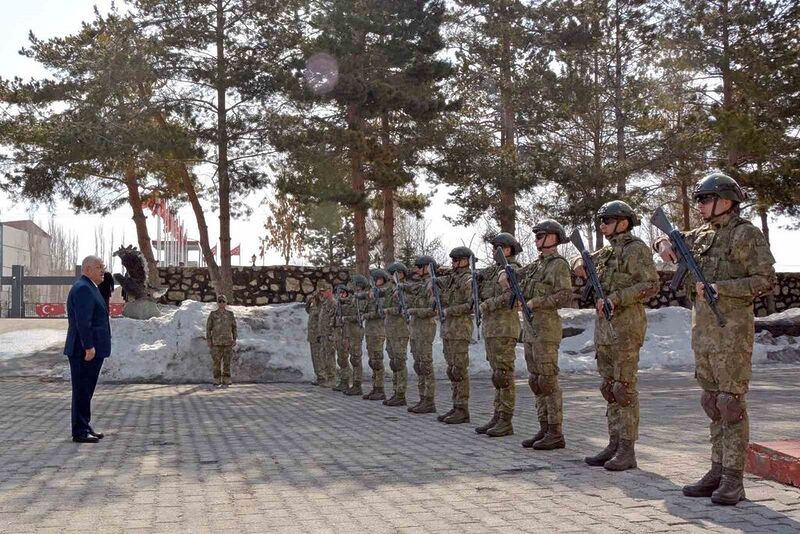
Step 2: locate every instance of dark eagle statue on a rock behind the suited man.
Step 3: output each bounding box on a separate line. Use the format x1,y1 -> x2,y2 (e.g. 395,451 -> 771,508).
114,245 -> 166,319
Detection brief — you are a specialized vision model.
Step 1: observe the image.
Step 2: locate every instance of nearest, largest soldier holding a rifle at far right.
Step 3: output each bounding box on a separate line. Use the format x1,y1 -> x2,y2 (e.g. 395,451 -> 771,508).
654,173 -> 775,505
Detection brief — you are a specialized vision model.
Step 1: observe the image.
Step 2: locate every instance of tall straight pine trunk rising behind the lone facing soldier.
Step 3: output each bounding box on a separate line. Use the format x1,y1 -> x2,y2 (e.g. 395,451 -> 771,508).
215,0 -> 233,303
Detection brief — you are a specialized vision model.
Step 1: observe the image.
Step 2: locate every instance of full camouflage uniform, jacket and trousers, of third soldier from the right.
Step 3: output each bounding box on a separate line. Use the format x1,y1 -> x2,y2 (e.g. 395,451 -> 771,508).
519,252 -> 572,425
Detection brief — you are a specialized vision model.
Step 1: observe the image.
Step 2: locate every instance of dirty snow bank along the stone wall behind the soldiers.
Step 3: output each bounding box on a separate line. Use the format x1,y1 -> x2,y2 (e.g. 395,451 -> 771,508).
90,301 -> 798,382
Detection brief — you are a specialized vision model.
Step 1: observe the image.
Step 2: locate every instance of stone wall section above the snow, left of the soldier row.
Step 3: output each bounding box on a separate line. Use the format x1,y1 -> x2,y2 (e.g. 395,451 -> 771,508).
158,266 -> 350,306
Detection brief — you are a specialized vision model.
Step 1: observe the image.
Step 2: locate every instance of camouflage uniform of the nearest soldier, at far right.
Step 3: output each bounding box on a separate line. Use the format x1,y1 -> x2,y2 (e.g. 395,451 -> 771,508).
656,212 -> 775,470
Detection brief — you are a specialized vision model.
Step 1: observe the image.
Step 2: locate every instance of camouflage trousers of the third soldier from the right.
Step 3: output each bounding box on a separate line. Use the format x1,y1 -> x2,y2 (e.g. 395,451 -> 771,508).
525,341 -> 563,425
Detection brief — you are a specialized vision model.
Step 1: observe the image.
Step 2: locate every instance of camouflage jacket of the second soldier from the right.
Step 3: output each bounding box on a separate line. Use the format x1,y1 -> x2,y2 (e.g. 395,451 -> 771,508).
592,232 -> 660,347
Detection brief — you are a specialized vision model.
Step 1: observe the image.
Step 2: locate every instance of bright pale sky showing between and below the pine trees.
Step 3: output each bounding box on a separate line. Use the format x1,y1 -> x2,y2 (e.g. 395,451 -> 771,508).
0,0 -> 800,271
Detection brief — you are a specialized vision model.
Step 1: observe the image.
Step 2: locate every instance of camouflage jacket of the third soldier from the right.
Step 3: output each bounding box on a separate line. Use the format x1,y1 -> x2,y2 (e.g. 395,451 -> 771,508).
519,252 -> 572,343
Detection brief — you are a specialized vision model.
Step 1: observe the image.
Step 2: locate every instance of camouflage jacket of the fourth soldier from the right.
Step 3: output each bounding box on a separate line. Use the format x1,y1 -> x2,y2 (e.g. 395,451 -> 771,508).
480,256 -> 520,339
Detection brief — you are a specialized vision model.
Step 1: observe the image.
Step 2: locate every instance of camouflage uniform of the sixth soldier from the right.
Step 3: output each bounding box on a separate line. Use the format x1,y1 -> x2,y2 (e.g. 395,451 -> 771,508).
406,278 -> 436,398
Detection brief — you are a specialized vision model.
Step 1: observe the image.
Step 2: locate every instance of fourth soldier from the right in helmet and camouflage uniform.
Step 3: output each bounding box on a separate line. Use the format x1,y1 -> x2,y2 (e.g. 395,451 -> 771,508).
475,232 -> 522,437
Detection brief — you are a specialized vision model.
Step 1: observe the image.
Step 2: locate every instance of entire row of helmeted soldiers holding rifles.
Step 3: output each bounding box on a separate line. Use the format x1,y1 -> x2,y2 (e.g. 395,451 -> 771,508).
308,173 -> 775,504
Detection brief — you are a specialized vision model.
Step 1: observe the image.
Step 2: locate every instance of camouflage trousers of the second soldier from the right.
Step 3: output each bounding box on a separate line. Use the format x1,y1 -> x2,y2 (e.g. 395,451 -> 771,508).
596,345 -> 641,441
